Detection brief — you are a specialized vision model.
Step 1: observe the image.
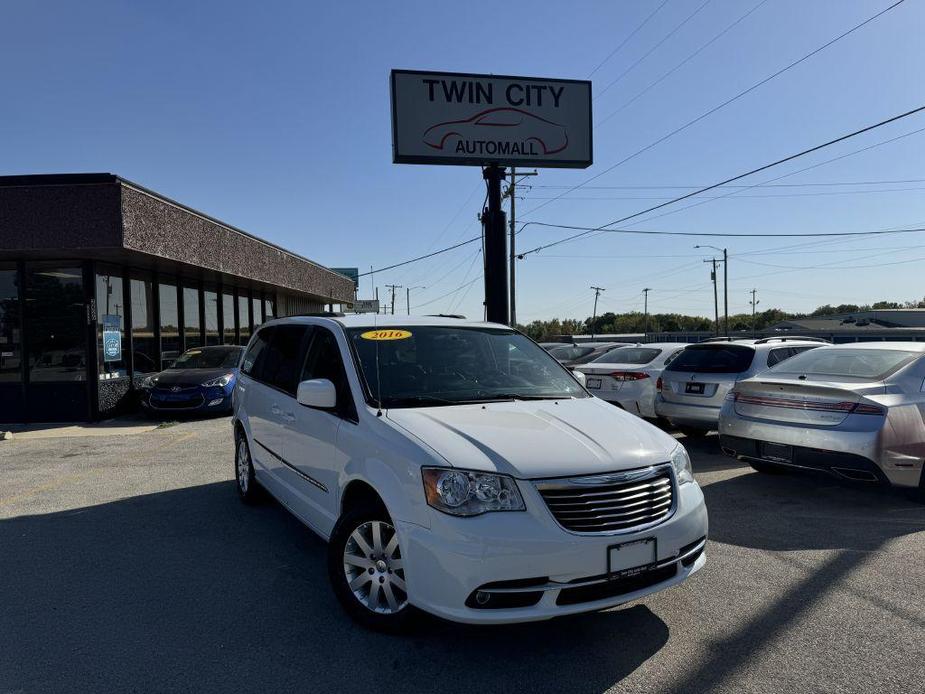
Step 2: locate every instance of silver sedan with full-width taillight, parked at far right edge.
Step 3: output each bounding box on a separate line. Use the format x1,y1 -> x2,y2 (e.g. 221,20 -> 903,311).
719,342 -> 925,490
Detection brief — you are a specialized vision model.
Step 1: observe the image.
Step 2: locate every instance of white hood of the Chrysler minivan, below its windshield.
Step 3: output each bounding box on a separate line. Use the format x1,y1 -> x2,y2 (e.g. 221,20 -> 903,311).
387,398 -> 677,479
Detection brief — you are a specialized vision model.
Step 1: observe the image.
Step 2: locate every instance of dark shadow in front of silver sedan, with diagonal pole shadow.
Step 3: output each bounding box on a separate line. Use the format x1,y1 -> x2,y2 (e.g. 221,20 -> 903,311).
675,461 -> 925,692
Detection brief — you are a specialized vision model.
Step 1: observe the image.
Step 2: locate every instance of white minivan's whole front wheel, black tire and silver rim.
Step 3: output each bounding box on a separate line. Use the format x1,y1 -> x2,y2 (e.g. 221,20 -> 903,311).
328,506 -> 415,633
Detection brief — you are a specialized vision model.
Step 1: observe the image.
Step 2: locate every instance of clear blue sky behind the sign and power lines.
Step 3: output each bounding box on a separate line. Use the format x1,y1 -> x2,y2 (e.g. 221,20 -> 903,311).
0,0 -> 925,321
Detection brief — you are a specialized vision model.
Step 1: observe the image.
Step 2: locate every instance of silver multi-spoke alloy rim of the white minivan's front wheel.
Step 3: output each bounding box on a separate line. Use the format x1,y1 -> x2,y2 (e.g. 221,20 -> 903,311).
344,520 -> 408,614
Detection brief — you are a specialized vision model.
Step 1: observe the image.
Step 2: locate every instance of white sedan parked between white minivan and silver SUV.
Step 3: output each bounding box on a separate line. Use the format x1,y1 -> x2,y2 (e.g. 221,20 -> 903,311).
575,342 -> 687,419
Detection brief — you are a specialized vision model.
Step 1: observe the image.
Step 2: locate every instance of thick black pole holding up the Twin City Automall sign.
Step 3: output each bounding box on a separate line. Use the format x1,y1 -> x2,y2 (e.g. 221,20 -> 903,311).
482,164 -> 510,325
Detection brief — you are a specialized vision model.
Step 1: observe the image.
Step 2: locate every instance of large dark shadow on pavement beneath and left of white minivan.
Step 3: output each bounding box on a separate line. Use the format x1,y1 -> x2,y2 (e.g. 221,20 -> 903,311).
0,482 -> 668,693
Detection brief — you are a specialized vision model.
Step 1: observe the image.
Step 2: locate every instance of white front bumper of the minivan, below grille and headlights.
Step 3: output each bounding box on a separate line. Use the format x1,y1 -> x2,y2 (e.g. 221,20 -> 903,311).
398,482 -> 707,624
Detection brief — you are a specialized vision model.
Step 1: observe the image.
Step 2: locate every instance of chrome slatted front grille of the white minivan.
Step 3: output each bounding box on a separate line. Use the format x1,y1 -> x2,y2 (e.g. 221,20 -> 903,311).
535,465 -> 674,533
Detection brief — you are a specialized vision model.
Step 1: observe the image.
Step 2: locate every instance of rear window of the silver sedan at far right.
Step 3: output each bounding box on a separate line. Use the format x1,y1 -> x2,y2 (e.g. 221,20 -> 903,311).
771,347 -> 921,381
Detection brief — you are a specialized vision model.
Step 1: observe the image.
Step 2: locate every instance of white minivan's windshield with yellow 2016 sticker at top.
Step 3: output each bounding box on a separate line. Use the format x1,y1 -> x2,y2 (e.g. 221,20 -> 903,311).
346,325 -> 589,408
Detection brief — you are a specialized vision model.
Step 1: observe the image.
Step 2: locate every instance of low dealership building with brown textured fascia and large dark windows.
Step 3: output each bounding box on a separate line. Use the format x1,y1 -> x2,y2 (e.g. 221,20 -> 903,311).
0,174 -> 354,422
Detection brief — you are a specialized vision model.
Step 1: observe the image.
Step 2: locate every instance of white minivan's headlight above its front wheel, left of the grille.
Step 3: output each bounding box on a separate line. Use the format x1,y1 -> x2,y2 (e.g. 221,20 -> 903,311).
421,467 -> 525,516
